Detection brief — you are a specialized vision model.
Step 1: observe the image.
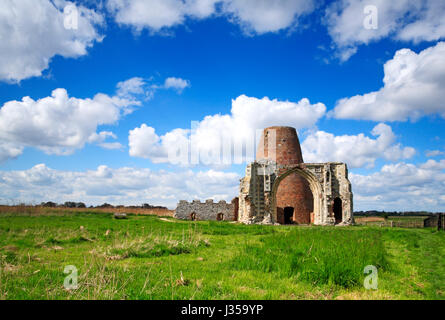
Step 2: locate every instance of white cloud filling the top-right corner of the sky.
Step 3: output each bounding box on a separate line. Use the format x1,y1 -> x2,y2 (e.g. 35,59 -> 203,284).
326,0 -> 445,61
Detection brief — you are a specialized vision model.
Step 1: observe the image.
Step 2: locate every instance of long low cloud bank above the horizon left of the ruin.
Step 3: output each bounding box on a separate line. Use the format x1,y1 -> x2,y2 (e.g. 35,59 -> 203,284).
0,164 -> 240,208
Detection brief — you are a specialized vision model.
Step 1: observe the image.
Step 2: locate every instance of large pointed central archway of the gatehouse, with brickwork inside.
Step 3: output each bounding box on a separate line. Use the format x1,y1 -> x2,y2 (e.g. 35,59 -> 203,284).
271,167 -> 323,224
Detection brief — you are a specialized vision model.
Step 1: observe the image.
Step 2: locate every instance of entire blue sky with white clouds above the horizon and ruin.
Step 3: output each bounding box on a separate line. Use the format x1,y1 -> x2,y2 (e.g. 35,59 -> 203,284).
0,0 -> 445,211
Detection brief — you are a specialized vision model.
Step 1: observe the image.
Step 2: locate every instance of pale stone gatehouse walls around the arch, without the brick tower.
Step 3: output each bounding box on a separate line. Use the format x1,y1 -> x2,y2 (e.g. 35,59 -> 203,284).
239,161 -> 353,225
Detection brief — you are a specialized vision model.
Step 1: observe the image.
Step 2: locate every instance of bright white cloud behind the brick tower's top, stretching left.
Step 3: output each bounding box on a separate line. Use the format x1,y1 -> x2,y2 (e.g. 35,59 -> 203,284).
129,95 -> 326,165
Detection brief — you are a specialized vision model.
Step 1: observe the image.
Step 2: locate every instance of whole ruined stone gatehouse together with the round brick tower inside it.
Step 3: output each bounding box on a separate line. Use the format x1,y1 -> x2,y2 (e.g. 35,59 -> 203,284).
238,127 -> 353,225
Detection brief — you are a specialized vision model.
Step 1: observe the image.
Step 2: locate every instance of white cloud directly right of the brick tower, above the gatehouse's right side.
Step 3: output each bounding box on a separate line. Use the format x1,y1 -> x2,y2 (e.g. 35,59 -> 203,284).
301,123 -> 416,168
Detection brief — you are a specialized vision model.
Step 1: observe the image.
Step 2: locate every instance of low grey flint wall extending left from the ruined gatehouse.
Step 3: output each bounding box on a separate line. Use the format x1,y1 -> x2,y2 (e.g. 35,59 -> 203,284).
174,199 -> 238,221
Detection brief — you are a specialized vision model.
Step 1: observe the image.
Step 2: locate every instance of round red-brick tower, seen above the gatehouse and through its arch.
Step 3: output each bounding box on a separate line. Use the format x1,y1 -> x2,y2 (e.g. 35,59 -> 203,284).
257,127 -> 314,224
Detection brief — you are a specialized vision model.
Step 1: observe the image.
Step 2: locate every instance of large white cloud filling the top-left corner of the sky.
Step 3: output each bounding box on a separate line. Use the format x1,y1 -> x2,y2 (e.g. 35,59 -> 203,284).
0,0 -> 103,82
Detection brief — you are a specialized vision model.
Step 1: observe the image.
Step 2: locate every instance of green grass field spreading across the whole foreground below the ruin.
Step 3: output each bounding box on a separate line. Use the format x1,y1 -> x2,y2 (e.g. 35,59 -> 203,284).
0,212 -> 445,299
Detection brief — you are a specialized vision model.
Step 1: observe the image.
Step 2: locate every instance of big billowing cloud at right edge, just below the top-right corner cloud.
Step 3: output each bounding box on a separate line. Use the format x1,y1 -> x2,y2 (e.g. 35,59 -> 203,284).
332,42 -> 445,121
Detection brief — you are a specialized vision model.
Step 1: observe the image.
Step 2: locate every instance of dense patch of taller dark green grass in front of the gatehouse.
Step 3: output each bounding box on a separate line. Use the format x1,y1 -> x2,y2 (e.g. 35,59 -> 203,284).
230,228 -> 388,288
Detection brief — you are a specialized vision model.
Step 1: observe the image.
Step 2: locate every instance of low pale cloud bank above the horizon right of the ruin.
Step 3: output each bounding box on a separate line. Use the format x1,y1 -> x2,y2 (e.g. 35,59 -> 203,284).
349,160 -> 445,211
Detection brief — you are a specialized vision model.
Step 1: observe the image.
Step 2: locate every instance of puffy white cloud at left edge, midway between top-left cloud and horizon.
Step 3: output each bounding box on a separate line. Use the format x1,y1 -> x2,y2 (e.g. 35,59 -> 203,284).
0,80 -> 140,160
